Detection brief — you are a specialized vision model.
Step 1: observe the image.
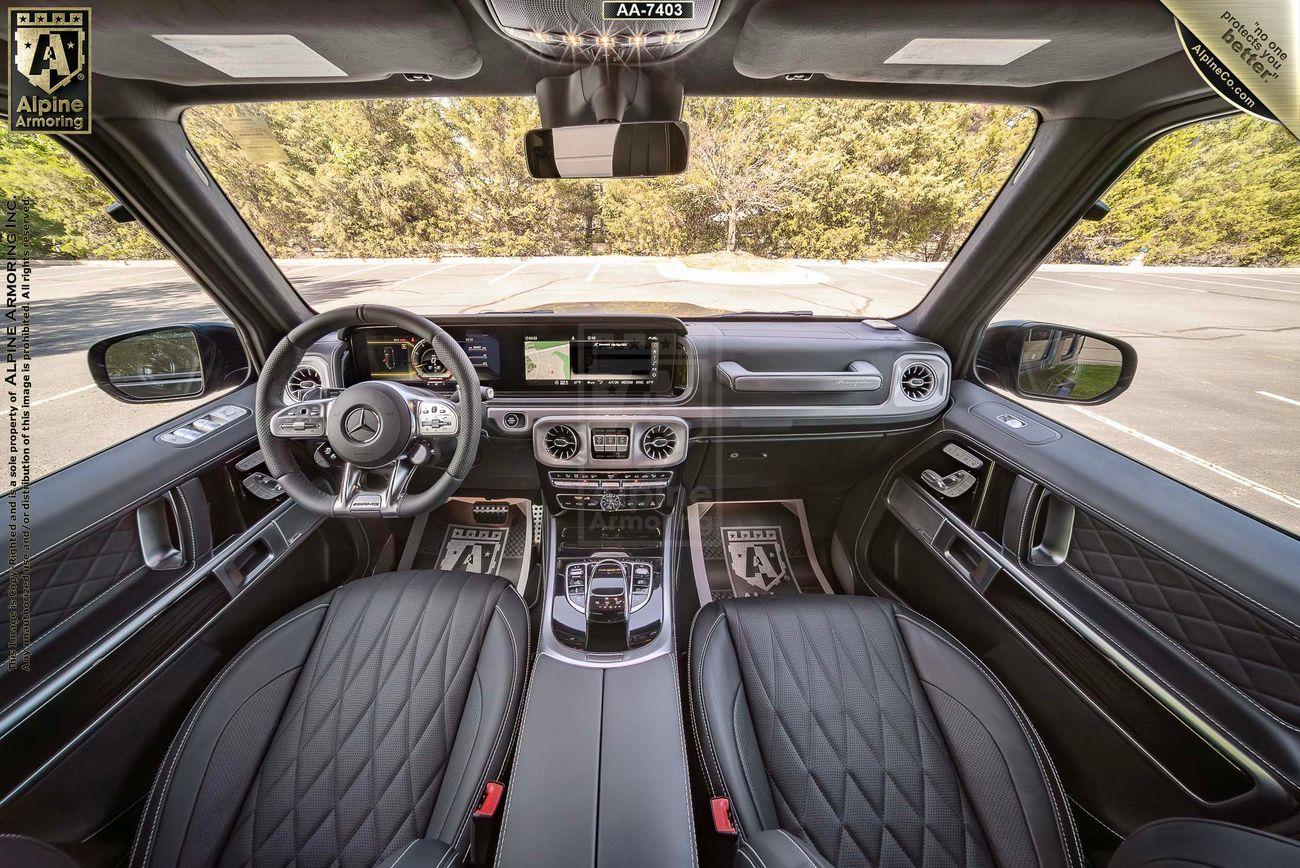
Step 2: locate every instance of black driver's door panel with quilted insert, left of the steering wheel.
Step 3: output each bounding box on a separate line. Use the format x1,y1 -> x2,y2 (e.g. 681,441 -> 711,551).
0,386 -> 359,842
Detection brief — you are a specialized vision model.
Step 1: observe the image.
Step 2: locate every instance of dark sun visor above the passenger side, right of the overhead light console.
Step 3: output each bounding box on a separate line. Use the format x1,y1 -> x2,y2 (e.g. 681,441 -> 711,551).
736,0 -> 1179,87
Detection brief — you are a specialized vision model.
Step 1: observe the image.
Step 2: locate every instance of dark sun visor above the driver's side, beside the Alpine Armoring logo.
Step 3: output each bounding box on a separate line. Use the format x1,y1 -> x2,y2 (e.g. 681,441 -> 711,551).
57,0 -> 482,86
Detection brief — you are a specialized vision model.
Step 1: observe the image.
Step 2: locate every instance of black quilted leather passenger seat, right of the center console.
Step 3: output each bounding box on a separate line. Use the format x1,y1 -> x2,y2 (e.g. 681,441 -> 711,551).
689,595 -> 1083,868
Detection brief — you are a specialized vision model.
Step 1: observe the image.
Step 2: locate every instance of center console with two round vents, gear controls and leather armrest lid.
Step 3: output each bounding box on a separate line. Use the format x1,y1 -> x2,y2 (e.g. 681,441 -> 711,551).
498,413 -> 698,867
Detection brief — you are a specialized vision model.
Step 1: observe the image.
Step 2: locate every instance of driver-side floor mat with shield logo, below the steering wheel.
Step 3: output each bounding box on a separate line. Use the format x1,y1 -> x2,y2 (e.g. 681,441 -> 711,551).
412,498 -> 533,594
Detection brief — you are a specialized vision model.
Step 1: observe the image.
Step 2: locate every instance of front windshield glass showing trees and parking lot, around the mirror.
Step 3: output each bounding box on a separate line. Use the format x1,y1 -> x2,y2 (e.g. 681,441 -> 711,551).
185,97 -> 1036,317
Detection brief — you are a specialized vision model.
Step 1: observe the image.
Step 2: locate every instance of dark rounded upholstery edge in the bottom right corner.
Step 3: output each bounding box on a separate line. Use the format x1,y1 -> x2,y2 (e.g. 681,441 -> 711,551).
1110,817 -> 1300,868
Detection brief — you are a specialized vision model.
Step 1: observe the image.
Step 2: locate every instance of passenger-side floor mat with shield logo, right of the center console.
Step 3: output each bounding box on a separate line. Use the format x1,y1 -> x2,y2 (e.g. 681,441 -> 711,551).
686,500 -> 832,606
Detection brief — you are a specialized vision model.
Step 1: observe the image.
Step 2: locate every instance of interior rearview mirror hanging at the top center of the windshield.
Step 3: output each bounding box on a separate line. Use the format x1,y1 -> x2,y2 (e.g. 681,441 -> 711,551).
524,121 -> 690,178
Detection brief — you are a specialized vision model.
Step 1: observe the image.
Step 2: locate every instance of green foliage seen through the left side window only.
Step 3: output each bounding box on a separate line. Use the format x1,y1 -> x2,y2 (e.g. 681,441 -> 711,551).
0,131 -> 165,259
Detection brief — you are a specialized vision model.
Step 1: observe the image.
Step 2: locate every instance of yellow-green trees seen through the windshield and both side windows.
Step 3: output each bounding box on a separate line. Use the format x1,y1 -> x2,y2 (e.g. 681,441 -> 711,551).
0,97 -> 1300,265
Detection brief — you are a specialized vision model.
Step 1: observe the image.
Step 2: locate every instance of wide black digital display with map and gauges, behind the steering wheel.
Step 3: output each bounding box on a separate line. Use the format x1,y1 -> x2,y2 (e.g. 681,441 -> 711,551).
346,318 -> 686,398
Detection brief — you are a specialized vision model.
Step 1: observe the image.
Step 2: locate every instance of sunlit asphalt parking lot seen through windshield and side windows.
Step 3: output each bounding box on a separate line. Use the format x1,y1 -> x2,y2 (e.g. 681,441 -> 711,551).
17,257 -> 1300,533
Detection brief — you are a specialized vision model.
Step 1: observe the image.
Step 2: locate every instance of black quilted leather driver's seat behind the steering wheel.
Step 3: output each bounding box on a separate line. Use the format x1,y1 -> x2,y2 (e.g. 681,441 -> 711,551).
131,570 -> 528,867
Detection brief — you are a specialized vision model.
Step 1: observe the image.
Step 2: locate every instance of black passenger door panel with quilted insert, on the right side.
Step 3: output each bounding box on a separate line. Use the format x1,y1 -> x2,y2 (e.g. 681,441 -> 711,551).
841,382 -> 1300,834
